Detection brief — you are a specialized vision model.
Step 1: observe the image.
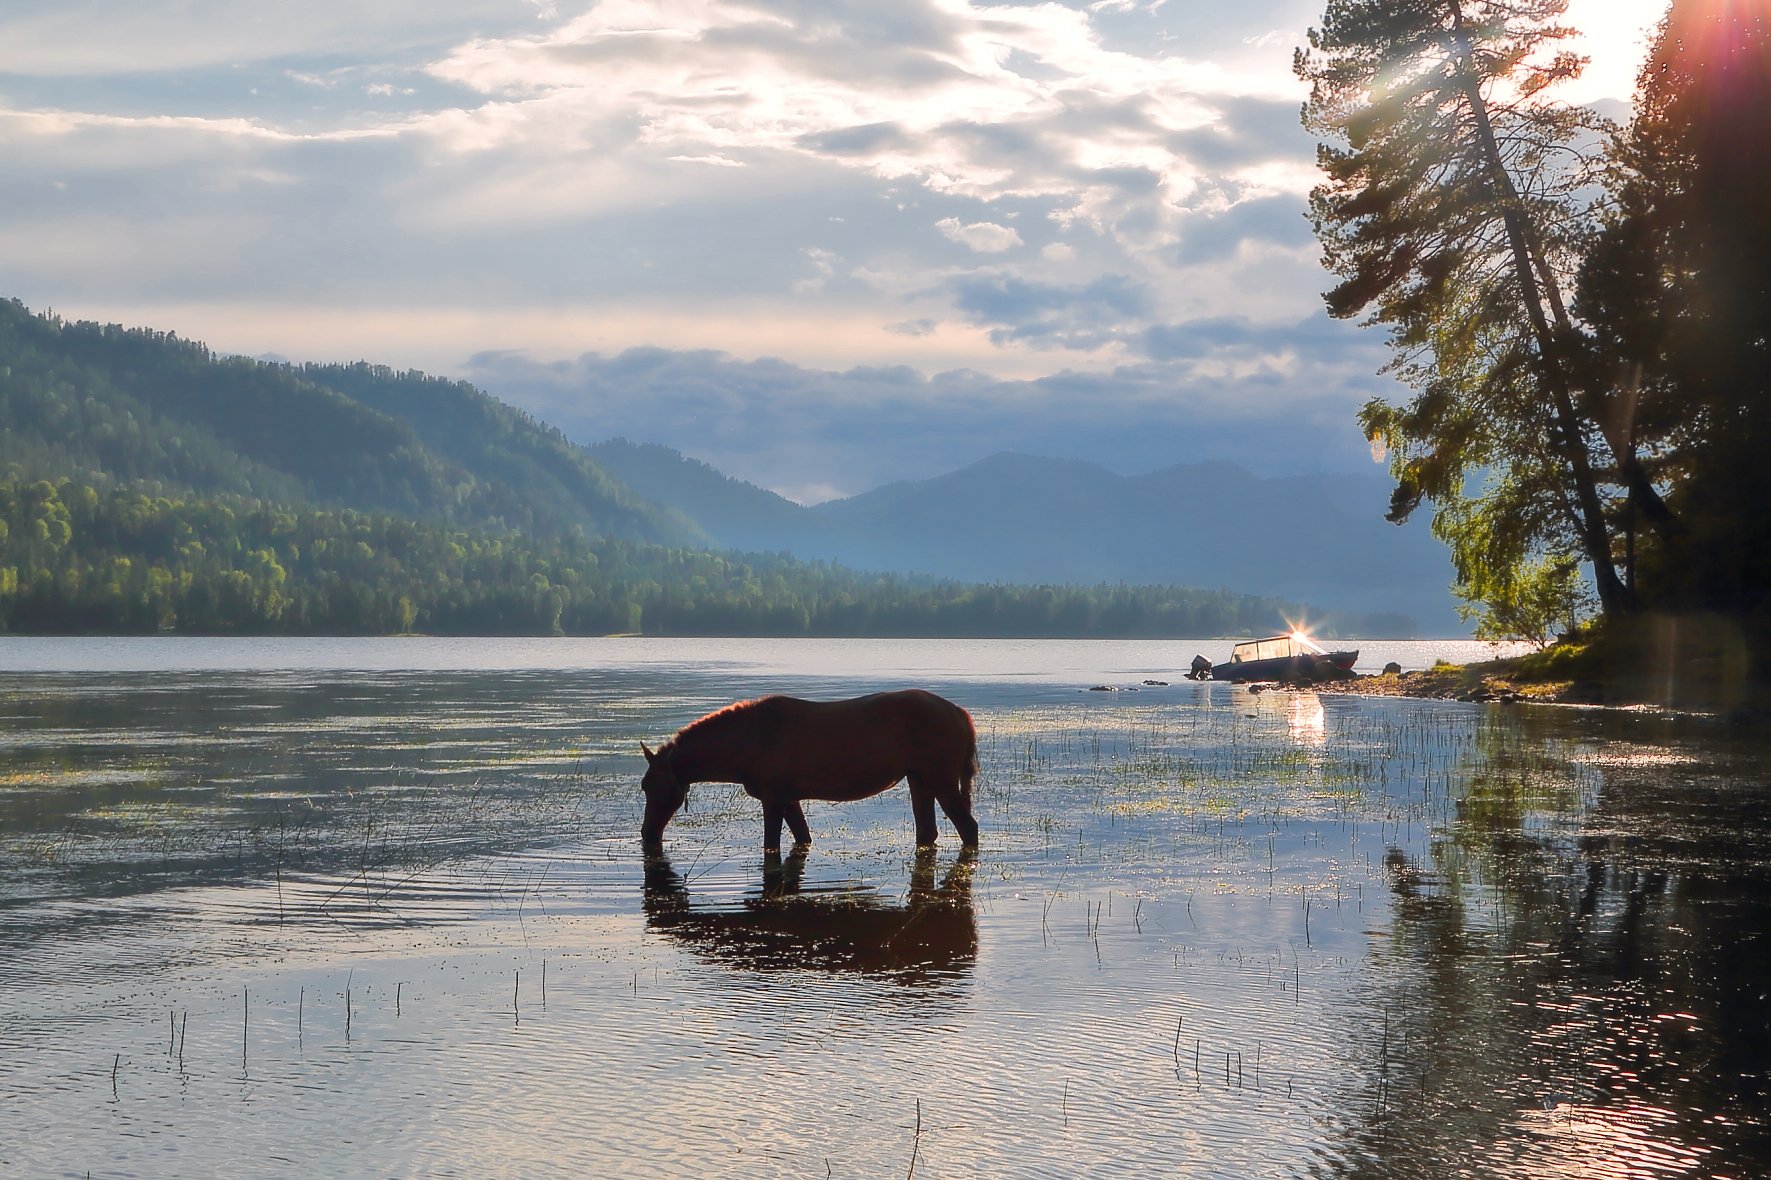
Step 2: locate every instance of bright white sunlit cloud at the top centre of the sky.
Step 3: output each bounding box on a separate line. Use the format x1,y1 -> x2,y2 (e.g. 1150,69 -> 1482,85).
414,0 -> 1296,226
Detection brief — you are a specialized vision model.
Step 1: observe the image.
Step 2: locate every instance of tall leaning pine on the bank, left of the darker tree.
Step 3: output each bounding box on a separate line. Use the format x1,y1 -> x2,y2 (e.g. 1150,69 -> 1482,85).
1295,0 -> 1629,623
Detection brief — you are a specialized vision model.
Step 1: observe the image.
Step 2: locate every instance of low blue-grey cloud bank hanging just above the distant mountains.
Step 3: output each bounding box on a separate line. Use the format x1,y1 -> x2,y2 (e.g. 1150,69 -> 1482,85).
462,340 -> 1387,505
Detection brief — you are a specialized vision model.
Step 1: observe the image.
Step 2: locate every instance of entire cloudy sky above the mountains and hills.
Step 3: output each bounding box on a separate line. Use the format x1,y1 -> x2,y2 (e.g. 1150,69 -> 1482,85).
0,0 -> 1665,503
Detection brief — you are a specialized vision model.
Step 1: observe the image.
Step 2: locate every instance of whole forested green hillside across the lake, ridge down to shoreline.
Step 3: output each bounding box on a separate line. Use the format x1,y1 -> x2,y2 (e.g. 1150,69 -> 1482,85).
0,301 -> 1411,636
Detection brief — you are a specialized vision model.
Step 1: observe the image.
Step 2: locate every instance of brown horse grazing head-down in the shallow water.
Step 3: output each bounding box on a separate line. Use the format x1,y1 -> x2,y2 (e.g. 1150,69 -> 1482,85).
639,689 -> 978,849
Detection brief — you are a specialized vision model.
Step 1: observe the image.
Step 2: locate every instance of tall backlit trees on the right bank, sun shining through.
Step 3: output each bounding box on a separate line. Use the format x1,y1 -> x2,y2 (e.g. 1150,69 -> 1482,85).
1296,0 -> 1771,654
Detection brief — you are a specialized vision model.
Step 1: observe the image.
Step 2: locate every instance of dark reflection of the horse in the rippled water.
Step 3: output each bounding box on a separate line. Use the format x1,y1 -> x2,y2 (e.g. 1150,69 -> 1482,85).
645,849 -> 978,985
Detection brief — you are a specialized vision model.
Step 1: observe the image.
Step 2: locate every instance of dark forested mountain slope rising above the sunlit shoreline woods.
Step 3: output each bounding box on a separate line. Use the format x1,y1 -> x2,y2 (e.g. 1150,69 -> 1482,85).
0,301 -> 690,544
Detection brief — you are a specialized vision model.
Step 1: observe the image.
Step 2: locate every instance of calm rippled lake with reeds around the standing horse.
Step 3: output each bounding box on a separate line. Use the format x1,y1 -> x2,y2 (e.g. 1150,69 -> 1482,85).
0,638 -> 1771,1178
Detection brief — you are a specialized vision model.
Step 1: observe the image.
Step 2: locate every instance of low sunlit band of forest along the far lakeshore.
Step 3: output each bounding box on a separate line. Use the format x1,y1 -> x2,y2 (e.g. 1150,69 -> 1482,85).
0,473 -> 1411,636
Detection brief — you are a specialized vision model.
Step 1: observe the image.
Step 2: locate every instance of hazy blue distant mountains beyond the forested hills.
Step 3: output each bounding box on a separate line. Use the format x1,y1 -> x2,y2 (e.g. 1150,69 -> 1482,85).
590,439 -> 1466,634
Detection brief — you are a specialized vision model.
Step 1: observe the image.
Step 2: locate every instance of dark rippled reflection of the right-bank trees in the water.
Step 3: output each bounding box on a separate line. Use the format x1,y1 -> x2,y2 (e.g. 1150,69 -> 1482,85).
1316,701 -> 1771,1176
